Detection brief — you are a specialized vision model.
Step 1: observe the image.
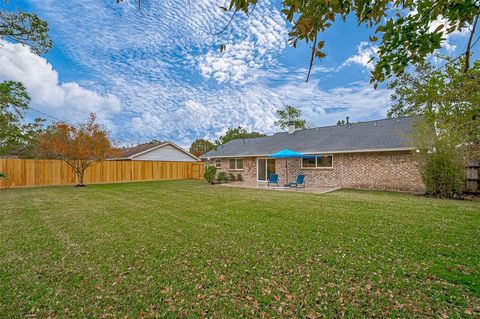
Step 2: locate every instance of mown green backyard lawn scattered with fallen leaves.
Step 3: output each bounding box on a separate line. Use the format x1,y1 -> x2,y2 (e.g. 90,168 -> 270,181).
0,181 -> 480,318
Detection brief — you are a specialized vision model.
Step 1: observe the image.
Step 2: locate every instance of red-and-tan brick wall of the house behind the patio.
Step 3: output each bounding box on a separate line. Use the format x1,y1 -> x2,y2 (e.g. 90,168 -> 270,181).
210,152 -> 424,191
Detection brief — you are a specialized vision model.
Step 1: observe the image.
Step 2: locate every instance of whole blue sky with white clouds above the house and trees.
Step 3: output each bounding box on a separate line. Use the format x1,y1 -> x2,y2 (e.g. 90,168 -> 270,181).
0,0 -> 465,146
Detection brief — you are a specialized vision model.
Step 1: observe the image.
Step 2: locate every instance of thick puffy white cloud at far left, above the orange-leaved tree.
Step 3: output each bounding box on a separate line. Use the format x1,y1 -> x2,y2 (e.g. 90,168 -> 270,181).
0,40 -> 121,125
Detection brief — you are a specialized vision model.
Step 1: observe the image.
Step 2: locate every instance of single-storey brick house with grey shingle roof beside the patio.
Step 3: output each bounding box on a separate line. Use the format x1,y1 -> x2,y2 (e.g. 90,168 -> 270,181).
201,117 -> 424,191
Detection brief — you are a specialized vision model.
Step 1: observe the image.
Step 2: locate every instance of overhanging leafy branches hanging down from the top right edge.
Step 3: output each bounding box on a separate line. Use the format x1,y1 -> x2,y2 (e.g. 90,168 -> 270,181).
225,0 -> 480,86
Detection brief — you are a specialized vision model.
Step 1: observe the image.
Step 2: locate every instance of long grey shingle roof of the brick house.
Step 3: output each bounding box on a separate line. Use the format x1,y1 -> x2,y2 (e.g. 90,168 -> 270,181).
201,117 -> 418,158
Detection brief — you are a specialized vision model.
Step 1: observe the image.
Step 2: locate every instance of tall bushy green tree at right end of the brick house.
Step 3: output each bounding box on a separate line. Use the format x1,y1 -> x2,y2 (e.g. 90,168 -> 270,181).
388,59 -> 480,197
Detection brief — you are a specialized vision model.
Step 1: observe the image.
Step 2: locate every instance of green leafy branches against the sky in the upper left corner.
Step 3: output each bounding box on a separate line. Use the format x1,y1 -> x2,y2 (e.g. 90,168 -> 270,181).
0,10 -> 52,54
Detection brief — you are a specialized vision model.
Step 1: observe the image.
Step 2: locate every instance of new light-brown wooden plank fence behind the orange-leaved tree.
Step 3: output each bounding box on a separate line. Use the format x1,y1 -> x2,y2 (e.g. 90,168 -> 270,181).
0,159 -> 204,188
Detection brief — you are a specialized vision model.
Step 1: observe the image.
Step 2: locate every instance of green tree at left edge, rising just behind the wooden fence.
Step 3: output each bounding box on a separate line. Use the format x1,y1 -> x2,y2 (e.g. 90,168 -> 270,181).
0,81 -> 43,156
